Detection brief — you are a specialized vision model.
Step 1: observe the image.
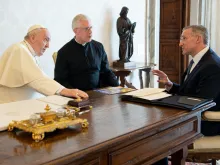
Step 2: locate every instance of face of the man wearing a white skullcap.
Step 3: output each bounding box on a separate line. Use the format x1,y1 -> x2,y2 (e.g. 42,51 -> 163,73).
33,29 -> 50,56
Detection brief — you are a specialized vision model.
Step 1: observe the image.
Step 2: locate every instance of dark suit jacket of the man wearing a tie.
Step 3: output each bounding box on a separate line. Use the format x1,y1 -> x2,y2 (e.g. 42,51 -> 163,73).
169,48 -> 220,110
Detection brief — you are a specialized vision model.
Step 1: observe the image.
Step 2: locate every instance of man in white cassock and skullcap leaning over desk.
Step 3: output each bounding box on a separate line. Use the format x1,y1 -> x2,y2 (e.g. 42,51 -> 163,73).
0,25 -> 88,104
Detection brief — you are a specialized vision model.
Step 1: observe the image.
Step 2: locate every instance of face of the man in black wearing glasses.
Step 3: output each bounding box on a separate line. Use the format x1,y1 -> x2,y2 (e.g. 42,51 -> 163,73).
74,20 -> 92,44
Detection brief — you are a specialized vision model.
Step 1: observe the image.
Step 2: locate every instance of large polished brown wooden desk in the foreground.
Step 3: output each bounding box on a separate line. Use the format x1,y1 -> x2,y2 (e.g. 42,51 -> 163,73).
0,92 -> 213,165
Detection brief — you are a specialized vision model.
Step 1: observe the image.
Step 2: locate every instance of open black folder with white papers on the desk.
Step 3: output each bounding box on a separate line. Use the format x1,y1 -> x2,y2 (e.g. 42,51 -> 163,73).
121,88 -> 215,110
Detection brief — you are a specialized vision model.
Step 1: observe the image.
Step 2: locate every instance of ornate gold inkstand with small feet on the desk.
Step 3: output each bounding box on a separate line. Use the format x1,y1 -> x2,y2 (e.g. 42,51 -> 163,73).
8,105 -> 89,142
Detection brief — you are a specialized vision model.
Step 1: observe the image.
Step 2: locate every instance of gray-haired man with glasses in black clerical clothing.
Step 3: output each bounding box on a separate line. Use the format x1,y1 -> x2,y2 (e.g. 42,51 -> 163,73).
54,14 -> 119,90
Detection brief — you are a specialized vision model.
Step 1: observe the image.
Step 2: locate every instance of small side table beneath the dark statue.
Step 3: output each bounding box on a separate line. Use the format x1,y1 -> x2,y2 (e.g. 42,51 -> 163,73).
110,62 -> 154,89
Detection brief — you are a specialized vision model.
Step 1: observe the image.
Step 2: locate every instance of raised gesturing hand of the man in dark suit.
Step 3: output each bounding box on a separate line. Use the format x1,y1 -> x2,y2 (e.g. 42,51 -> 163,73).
152,70 -> 173,88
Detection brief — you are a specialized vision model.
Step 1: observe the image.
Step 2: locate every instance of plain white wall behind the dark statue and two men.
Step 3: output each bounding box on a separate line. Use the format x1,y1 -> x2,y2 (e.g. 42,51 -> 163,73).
0,0 -> 148,85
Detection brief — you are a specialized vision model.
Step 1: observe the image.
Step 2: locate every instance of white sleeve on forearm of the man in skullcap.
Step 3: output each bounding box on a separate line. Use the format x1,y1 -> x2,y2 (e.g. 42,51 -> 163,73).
27,76 -> 64,96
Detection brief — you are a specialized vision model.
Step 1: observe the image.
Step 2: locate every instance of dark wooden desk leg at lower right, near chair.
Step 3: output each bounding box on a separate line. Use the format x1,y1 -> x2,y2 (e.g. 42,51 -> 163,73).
171,146 -> 188,165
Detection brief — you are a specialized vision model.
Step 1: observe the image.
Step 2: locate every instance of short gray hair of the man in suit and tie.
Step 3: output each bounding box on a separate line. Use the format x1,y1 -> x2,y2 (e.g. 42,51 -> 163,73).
183,25 -> 209,45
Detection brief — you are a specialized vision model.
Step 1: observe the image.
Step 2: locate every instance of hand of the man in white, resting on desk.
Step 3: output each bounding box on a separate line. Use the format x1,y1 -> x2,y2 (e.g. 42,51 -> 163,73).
60,88 -> 89,99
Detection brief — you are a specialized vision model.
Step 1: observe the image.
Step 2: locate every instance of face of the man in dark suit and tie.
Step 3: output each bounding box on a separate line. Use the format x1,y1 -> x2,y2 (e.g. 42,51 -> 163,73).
179,29 -> 198,56
